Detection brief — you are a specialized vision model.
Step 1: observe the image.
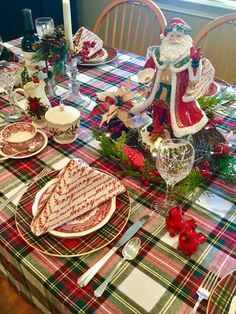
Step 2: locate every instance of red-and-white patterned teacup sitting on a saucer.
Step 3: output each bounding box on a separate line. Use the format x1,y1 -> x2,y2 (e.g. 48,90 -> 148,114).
1,122 -> 37,151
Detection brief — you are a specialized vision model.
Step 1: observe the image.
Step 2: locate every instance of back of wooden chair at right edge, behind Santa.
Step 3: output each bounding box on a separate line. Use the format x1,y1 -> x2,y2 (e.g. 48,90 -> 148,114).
193,13 -> 236,85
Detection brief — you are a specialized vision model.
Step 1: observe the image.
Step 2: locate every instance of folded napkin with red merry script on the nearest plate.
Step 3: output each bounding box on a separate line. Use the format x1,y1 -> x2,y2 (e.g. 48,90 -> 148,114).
31,159 -> 126,236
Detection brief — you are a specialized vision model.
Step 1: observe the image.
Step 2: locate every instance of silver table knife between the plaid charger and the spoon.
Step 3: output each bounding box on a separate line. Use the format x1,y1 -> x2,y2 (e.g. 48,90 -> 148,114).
77,215 -> 149,287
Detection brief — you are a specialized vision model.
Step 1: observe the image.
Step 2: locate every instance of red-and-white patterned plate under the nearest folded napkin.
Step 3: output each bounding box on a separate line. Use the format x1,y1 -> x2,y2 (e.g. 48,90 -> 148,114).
32,179 -> 116,238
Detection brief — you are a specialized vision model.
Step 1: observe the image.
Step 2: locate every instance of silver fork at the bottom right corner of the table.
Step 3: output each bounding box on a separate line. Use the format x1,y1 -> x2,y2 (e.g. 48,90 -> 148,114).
191,271 -> 219,314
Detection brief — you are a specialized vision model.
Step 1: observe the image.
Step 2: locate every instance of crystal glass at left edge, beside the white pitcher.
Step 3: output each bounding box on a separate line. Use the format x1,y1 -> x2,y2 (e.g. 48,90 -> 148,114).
0,62 -> 23,122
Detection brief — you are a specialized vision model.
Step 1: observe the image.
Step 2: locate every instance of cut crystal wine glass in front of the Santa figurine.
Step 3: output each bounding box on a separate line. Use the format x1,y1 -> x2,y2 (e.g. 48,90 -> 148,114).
152,138 -> 195,211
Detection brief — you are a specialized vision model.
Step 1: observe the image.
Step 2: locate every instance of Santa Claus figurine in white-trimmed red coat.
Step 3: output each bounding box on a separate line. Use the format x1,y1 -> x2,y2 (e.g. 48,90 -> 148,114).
135,18 -> 215,138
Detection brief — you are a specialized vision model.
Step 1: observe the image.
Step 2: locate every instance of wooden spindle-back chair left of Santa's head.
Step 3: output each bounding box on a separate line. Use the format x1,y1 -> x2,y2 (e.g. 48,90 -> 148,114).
93,0 -> 167,55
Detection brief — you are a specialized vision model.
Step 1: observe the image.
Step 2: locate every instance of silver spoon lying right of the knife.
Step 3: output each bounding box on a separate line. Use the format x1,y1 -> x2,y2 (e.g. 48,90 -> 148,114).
94,237 -> 141,297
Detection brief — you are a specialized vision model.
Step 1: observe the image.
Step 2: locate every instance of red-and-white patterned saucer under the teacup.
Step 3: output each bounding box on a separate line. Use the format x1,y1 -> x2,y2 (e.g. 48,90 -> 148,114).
0,130 -> 48,159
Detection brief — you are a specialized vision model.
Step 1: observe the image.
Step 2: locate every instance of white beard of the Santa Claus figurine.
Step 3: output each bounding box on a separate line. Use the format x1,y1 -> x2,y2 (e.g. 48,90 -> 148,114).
160,35 -> 193,63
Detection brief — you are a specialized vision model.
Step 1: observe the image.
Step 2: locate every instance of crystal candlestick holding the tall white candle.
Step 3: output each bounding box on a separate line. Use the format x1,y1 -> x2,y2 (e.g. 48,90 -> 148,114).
62,58 -> 90,107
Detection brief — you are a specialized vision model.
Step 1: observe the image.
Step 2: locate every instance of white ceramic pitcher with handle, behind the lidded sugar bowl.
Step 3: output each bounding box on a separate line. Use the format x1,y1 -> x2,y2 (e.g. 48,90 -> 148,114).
14,80 -> 51,110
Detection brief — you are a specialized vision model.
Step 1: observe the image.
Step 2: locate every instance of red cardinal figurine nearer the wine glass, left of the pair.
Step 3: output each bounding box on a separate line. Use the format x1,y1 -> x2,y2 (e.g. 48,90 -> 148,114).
166,206 -> 197,237
